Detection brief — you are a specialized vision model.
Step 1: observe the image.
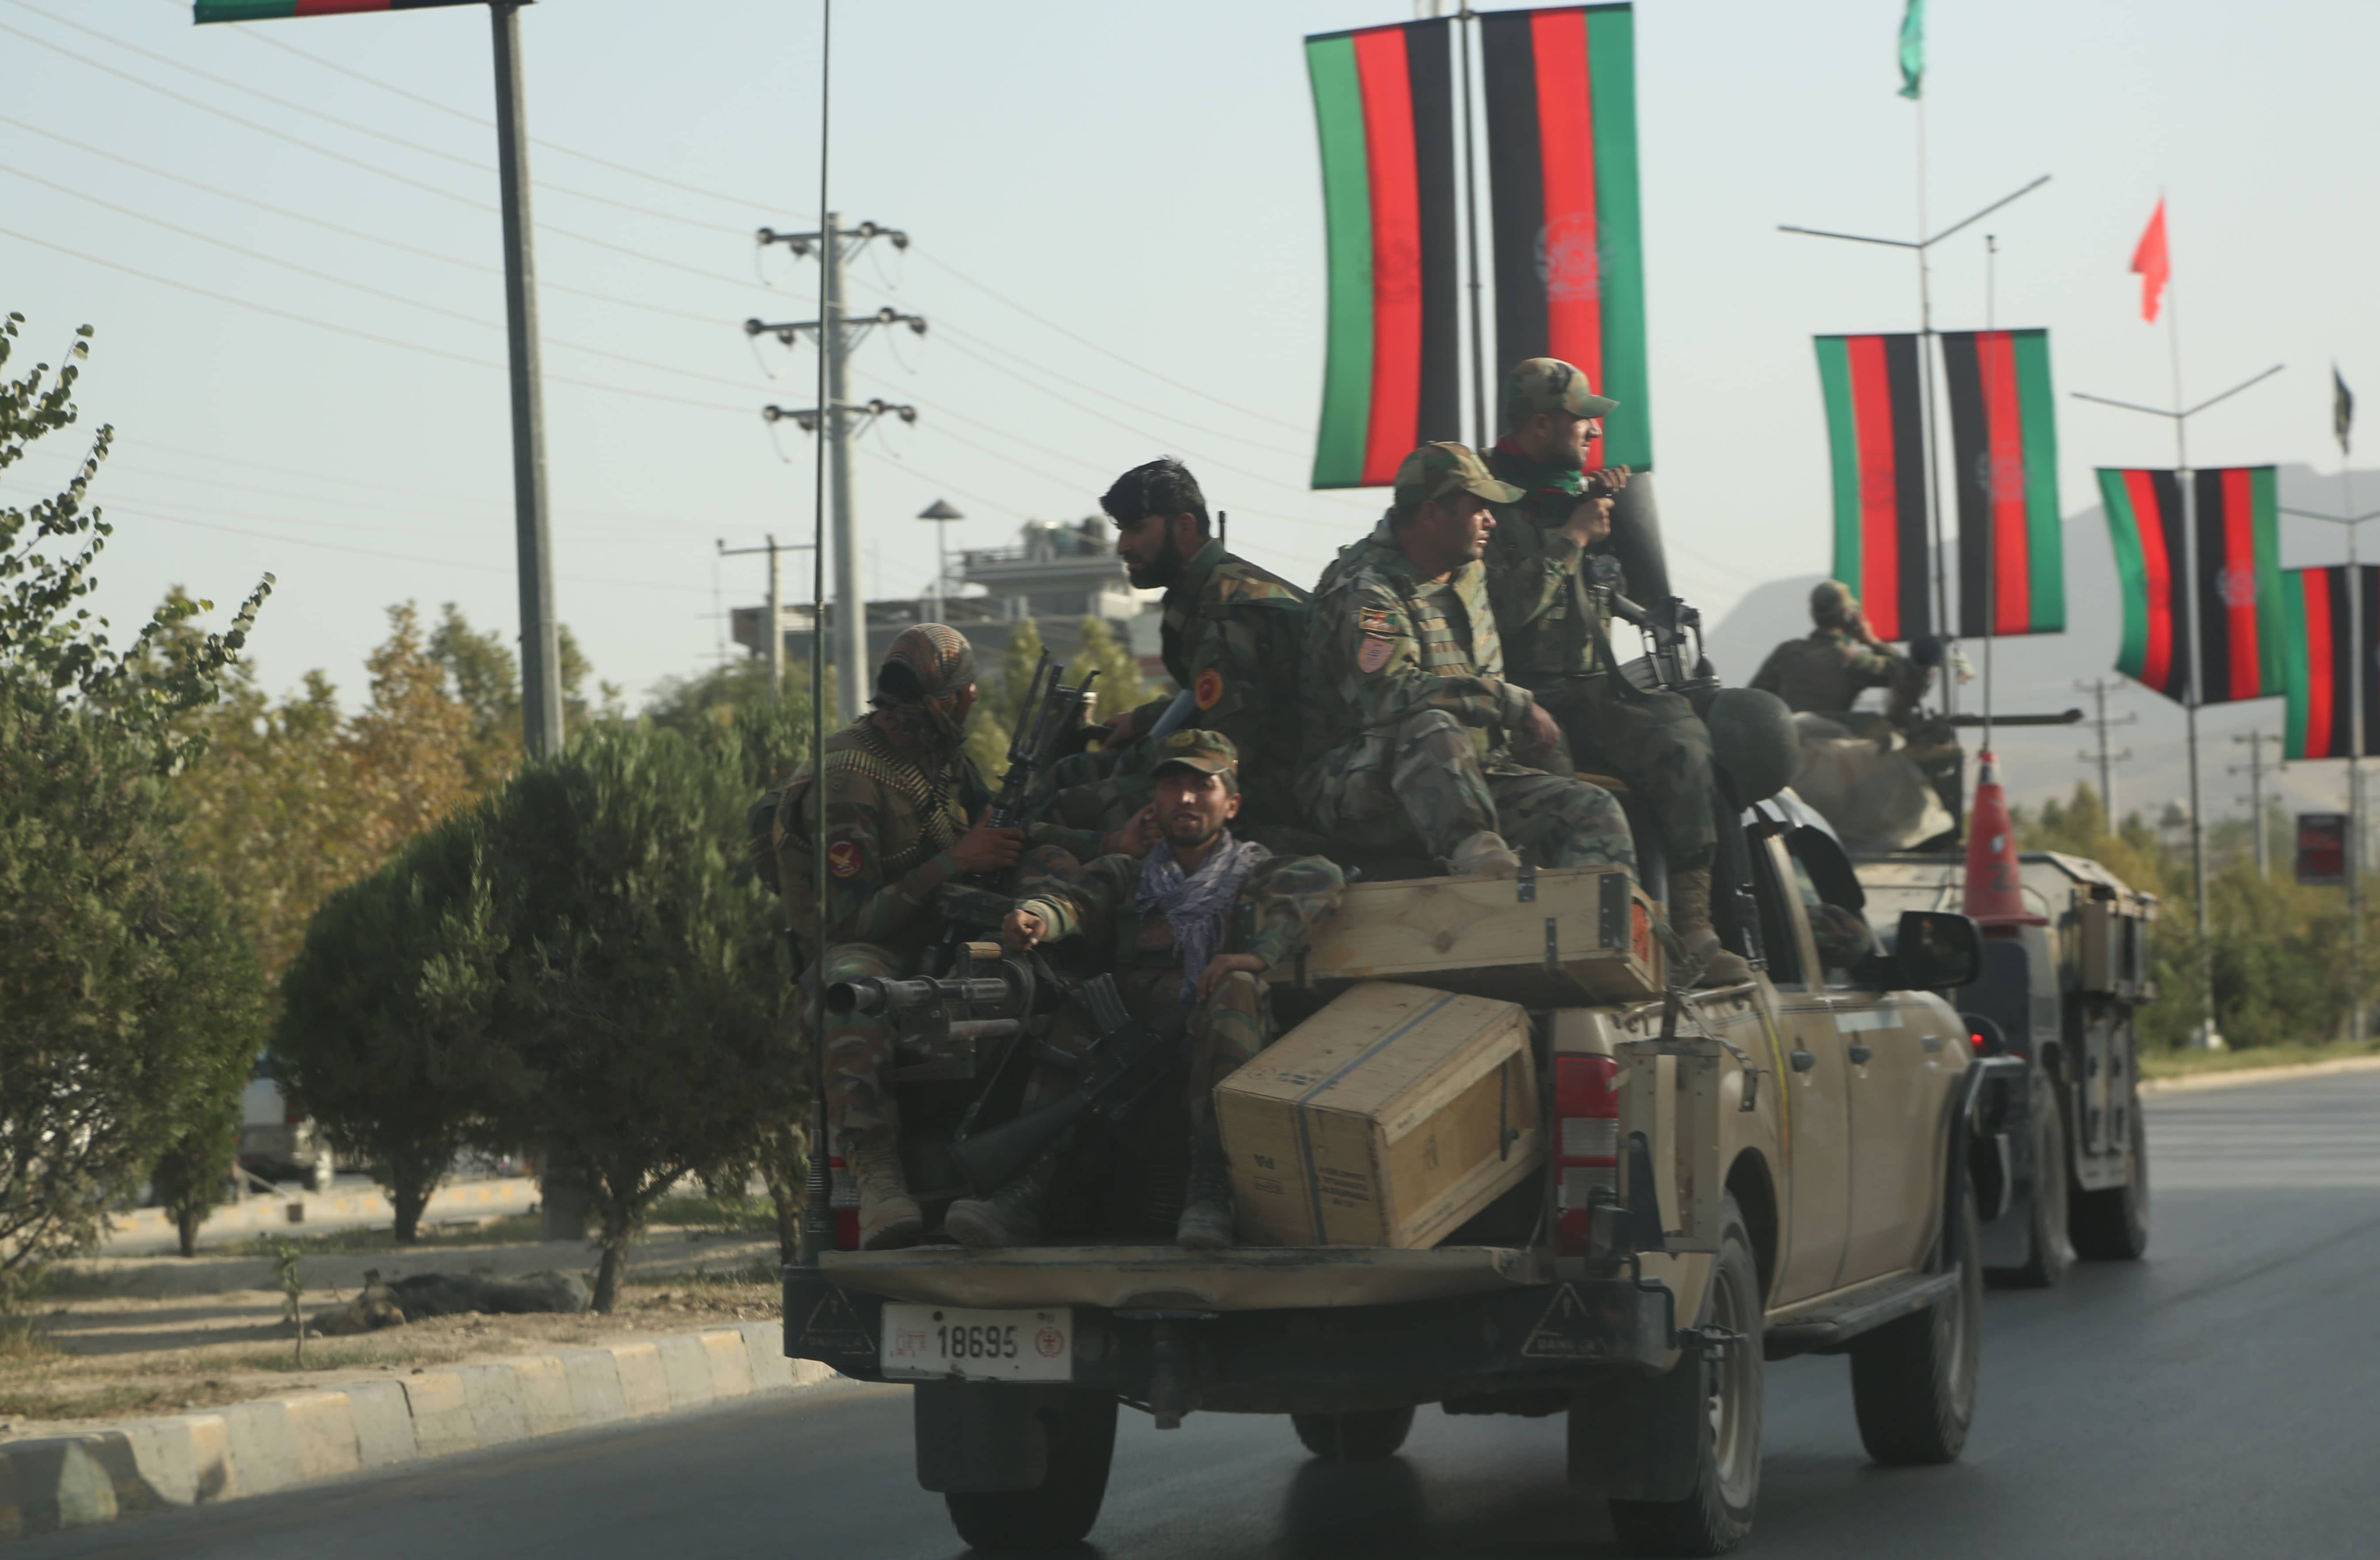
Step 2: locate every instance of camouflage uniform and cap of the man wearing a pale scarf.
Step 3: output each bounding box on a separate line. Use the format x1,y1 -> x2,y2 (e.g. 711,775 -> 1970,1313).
1016,731 -> 1347,1141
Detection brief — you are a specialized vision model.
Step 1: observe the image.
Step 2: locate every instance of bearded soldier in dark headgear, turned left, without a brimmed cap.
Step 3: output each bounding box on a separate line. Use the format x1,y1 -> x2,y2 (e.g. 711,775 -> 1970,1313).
1033,455 -> 1307,829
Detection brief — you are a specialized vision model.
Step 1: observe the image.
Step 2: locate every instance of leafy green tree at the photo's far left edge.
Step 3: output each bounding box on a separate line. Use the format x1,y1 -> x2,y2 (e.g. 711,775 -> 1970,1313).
0,314 -> 271,1291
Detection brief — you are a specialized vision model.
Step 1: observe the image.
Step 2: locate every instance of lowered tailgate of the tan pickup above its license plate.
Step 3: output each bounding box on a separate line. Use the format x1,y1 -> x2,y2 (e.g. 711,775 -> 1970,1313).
819,1246 -> 1554,1310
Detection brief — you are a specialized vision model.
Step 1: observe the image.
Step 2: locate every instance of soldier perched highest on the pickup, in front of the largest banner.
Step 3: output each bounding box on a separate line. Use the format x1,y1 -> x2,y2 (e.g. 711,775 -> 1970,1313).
1483,357 -> 1752,986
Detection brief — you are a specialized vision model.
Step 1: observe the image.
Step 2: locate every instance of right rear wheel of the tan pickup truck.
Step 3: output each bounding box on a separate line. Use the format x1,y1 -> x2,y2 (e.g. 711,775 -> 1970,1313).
1609,1196 -> 1764,1555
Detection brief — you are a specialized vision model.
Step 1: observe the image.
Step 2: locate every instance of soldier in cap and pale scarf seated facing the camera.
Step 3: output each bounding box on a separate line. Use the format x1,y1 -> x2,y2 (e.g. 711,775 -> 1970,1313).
1002,731 -> 1347,1250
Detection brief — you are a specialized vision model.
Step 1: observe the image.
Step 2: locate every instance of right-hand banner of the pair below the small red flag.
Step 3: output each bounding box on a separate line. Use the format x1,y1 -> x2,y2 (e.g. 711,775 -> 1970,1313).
2192,467 -> 2285,705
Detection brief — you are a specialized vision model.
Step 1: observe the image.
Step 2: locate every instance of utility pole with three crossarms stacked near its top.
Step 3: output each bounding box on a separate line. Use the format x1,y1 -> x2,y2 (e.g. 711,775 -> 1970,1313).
745,212 -> 926,717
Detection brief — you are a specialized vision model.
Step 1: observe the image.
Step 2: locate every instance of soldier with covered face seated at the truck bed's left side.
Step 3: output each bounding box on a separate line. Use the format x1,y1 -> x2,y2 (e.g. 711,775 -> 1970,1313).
774,624 -> 1145,1250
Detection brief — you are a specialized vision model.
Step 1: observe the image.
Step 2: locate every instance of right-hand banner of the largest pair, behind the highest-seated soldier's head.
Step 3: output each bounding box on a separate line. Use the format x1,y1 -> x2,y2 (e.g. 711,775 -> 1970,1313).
1480,5 -> 1652,471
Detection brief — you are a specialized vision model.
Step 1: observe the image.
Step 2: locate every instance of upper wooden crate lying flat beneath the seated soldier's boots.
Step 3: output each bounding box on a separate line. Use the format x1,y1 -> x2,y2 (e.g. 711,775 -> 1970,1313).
1290,867 -> 1661,1007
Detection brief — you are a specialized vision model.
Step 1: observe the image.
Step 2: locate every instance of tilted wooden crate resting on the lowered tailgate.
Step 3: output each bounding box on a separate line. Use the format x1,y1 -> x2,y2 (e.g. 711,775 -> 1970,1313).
1214,981 -> 1545,1248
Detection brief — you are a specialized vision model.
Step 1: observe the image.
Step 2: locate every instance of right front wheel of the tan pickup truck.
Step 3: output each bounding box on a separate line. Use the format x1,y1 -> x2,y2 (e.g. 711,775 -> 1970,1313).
1852,1191 -> 1983,1467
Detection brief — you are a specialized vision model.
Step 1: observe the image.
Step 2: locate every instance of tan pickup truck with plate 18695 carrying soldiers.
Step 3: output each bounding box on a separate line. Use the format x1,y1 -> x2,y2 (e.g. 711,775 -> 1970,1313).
786,798 -> 2021,1553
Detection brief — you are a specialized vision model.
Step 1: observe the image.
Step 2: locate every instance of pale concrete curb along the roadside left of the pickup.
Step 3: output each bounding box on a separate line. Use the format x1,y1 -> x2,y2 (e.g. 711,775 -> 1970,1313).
0,1322 -> 840,1541
